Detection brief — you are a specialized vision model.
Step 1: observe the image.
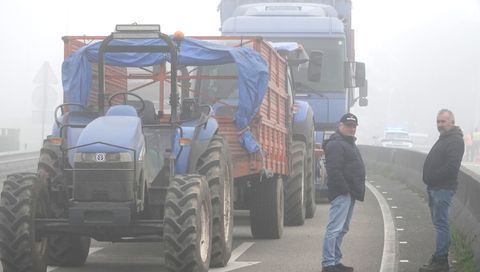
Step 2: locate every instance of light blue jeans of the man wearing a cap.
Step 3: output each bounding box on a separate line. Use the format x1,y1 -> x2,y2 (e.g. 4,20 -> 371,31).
322,194 -> 355,267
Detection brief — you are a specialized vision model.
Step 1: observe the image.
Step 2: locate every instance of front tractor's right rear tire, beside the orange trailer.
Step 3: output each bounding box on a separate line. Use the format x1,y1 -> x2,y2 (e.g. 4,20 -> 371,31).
197,136 -> 233,267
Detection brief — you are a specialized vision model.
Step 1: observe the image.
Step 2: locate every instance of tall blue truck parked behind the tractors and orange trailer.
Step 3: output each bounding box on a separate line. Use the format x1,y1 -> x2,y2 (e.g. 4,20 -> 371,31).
219,0 -> 368,199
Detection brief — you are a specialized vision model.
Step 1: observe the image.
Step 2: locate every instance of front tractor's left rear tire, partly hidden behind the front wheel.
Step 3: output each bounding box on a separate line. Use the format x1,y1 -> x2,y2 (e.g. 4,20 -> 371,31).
37,141 -> 90,267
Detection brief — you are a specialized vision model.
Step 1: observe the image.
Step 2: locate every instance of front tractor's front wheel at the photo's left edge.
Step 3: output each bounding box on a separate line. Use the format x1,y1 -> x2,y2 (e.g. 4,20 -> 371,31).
0,173 -> 48,272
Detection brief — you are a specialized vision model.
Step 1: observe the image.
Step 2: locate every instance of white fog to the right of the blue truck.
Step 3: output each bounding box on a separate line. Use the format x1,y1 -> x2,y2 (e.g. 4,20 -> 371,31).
352,0 -> 480,144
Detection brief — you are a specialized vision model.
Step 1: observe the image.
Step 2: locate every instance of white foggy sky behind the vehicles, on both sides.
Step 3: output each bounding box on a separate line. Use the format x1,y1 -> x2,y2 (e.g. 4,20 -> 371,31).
0,0 -> 480,150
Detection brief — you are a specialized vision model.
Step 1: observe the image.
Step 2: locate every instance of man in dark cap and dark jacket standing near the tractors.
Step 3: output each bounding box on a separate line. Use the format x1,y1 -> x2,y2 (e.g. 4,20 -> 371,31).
322,113 -> 365,272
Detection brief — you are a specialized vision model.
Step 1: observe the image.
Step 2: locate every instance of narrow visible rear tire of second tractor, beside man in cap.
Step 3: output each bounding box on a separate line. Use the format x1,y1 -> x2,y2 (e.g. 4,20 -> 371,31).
305,129 -> 317,218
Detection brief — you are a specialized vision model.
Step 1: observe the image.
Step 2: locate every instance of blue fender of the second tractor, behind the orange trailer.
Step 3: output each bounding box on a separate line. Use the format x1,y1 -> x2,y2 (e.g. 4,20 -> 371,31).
293,100 -> 314,142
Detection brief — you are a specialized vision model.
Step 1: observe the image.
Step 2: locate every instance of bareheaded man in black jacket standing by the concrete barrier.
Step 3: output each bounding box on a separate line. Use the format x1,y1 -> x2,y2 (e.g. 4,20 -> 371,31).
419,109 -> 465,272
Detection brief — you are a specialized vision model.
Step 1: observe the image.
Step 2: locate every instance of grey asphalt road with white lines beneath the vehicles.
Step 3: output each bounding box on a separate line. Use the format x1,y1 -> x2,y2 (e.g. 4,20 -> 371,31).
0,171 -> 440,272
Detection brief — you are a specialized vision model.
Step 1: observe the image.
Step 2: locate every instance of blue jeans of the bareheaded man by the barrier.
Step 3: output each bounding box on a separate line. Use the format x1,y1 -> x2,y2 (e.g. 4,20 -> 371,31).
427,188 -> 455,257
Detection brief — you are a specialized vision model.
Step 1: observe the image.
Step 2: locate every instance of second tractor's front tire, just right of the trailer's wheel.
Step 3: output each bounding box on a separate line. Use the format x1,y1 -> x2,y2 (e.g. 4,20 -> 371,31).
285,141 -> 306,226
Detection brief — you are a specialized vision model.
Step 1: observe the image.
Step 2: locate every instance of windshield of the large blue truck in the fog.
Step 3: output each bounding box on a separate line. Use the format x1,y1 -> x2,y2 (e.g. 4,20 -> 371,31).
269,37 -> 346,92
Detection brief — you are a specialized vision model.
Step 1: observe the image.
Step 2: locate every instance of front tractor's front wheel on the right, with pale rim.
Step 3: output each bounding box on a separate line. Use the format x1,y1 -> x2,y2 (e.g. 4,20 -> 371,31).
163,175 -> 212,272
